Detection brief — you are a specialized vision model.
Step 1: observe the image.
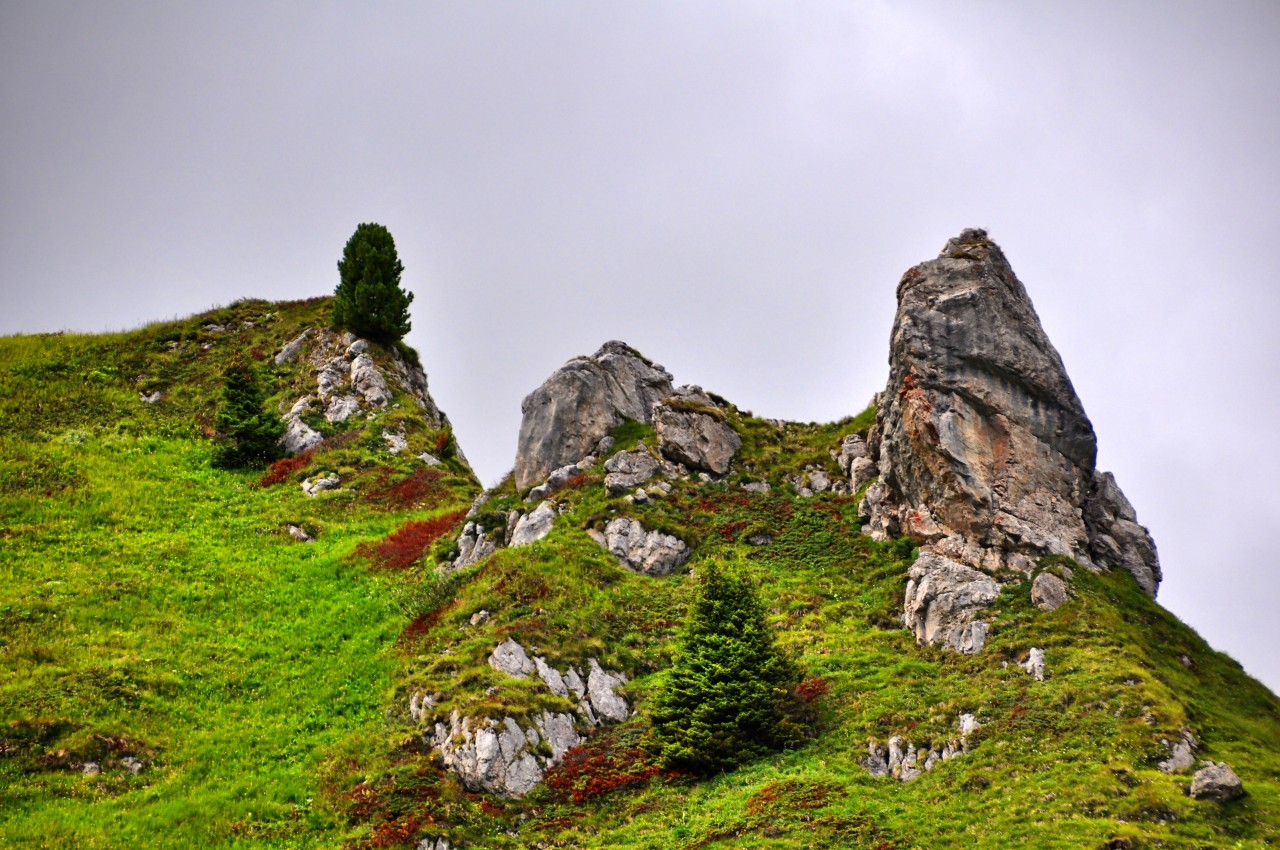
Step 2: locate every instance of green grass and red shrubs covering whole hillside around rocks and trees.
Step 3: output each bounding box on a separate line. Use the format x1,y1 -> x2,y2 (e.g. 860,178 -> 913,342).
0,302 -> 1280,850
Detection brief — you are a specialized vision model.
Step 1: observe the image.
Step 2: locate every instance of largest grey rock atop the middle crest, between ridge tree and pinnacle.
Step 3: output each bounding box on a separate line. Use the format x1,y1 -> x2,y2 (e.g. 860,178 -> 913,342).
516,342 -> 672,490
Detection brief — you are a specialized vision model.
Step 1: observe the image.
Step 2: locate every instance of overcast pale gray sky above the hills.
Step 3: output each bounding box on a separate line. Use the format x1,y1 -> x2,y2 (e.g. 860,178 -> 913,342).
0,0 -> 1280,690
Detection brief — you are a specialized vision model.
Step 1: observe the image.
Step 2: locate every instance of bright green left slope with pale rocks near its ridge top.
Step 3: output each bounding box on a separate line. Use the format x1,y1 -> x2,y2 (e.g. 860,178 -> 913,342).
0,300 -> 479,847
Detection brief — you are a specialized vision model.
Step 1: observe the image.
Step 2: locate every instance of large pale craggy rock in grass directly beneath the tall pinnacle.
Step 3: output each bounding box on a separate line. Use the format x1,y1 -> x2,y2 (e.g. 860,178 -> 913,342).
902,552 -> 1000,654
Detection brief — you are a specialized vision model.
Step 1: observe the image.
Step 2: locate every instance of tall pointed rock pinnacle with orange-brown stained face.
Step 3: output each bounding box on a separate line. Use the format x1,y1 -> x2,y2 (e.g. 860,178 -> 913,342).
865,230 -> 1160,650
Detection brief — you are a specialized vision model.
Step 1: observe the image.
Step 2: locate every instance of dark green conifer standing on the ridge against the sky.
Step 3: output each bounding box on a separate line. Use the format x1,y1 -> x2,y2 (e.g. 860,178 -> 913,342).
333,224 -> 413,344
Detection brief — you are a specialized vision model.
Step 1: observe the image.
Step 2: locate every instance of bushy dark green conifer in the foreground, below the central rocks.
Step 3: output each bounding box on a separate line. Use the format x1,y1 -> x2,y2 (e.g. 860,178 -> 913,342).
653,561 -> 801,774
